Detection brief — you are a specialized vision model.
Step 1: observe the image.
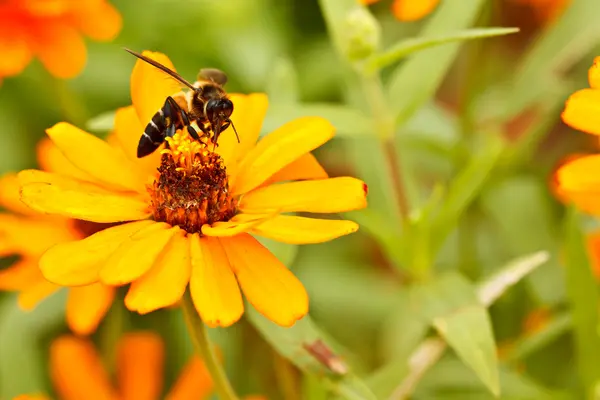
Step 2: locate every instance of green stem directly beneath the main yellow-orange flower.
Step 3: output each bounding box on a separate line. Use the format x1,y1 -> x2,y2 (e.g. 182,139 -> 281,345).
182,292 -> 238,400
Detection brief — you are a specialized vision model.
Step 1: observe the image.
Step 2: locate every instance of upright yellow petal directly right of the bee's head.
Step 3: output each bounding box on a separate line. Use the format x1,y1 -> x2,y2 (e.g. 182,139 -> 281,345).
217,93 -> 269,175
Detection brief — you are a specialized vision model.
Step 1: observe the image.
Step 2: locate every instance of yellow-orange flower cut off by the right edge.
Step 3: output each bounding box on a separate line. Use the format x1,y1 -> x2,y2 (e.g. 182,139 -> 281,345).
554,57 -> 600,215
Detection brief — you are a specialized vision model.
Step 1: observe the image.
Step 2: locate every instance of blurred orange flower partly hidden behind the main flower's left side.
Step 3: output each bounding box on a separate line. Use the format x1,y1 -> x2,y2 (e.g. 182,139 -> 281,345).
0,139 -> 114,335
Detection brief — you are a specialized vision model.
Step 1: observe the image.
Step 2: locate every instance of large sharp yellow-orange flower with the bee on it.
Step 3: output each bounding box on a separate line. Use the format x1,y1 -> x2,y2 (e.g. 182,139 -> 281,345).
19,52 -> 367,326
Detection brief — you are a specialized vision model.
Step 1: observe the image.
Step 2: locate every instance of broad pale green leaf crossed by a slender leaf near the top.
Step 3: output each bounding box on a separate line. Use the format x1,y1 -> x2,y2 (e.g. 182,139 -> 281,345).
387,0 -> 487,124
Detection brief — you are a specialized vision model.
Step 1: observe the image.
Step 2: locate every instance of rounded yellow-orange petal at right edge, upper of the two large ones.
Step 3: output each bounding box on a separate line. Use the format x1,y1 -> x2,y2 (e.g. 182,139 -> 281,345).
562,89 -> 600,135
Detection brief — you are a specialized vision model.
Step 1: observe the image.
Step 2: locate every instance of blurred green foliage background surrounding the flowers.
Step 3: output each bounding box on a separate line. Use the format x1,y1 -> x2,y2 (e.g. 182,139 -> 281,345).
5,0 -> 600,400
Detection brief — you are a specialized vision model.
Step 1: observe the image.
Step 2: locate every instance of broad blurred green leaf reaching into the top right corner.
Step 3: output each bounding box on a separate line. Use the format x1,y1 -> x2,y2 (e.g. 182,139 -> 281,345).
505,0 -> 600,120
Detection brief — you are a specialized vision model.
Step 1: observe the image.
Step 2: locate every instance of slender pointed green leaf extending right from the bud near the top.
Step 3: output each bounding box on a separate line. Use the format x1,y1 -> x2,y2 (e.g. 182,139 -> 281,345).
364,28 -> 519,74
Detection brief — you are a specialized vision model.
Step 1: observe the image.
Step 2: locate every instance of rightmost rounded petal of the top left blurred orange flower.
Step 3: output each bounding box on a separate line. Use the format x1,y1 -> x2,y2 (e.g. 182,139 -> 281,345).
70,1 -> 123,41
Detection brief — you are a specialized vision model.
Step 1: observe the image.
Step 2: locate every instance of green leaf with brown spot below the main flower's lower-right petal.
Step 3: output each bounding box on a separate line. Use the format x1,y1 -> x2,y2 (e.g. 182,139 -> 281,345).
246,306 -> 376,400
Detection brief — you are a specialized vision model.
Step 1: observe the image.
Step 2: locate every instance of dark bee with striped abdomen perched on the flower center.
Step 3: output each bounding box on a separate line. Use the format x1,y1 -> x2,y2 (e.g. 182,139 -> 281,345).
125,49 -> 240,158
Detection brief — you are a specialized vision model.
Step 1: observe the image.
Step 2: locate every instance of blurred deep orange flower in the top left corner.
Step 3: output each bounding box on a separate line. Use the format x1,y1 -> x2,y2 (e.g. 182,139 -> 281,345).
0,0 -> 122,79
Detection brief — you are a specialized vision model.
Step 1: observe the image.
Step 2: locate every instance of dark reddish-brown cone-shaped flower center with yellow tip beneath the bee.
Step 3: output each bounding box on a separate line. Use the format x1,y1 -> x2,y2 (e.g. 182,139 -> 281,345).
148,131 -> 237,233
